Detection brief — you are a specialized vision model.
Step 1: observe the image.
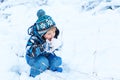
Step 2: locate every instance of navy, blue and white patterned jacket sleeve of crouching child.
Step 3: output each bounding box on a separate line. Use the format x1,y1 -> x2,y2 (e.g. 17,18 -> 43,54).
26,36 -> 44,57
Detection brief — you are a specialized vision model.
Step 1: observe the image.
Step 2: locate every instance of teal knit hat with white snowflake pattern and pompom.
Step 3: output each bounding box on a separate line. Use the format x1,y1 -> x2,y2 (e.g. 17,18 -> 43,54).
36,9 -> 55,35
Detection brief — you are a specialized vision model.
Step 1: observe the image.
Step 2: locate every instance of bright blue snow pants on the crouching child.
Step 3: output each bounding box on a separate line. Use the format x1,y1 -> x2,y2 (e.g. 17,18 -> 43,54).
26,53 -> 62,77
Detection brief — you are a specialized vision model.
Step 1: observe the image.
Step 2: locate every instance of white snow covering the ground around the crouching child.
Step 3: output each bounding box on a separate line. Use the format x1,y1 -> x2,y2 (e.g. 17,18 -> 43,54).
0,0 -> 120,80
